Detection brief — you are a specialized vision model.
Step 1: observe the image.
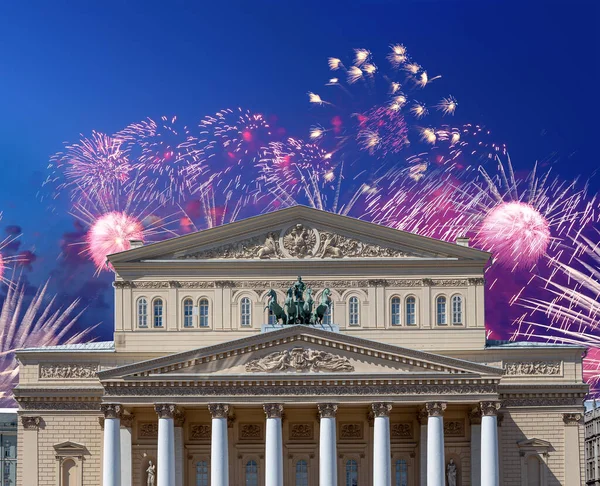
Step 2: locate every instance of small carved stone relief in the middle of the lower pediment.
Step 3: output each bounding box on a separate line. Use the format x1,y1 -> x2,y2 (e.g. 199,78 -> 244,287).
246,347 -> 354,373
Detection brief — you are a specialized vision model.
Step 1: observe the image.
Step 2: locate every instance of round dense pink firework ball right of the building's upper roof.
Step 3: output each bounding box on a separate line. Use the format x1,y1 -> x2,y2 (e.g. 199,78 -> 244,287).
477,201 -> 551,268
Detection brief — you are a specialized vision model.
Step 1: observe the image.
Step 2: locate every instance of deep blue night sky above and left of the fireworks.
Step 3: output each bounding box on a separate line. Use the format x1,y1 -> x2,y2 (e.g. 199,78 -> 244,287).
0,1 -> 600,339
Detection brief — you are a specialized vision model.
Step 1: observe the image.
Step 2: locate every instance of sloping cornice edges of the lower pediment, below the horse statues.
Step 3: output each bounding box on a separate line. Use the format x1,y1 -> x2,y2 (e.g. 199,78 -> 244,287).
98,324 -> 504,380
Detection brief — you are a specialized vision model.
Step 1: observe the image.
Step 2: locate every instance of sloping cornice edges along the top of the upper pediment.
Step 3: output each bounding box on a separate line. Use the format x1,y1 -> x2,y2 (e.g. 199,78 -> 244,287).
107,205 -> 492,265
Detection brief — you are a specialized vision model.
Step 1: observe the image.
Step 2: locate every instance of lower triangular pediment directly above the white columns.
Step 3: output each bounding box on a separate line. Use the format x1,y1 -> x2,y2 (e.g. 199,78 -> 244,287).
99,325 -> 503,381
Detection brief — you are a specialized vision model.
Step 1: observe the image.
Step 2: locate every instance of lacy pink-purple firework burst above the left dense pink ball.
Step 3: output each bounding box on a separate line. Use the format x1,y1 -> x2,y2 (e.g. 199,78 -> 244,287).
44,131 -> 132,199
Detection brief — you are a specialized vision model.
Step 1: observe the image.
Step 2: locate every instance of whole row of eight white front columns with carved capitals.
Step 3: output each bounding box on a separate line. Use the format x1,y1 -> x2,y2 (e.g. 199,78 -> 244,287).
102,401 -> 500,486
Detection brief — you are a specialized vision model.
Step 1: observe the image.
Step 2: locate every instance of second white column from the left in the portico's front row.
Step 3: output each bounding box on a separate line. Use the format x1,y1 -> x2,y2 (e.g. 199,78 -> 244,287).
154,403 -> 177,486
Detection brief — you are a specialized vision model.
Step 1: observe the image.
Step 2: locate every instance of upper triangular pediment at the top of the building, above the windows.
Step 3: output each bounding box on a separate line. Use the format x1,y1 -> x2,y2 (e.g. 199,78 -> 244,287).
109,206 -> 490,265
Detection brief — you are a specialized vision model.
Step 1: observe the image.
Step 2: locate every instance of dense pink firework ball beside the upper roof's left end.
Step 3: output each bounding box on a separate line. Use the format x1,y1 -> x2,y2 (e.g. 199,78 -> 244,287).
87,211 -> 144,269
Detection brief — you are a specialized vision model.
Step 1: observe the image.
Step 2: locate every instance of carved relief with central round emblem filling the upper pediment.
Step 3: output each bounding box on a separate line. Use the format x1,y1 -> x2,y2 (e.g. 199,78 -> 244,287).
177,223 -> 415,260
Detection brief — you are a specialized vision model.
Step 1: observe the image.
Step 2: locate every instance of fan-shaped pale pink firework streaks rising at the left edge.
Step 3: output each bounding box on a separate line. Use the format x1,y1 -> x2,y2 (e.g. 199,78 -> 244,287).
0,281 -> 95,406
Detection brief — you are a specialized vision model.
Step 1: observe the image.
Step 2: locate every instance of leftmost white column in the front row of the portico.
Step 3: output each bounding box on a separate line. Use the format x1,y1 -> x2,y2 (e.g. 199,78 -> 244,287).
100,403 -> 121,486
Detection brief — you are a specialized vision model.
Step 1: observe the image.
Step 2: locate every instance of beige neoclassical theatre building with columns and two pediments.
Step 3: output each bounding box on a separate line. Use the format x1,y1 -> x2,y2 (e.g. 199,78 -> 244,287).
15,206 -> 587,486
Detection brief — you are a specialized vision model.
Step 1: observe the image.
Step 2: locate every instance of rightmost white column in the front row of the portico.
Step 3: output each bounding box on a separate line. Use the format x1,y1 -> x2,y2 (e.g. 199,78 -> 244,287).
479,402 -> 500,486
